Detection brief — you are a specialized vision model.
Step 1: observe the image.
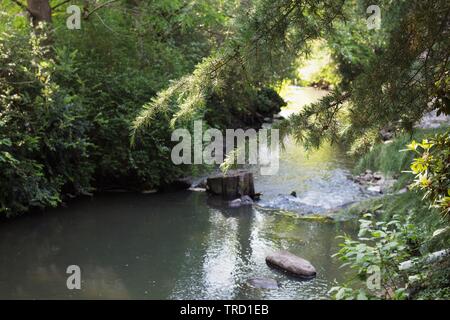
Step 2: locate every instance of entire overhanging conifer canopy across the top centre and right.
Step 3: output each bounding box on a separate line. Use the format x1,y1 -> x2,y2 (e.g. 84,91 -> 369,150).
134,0 -> 450,152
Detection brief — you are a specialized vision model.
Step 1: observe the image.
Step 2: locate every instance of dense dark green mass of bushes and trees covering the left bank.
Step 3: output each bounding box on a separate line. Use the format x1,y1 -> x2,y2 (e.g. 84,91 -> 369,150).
0,0 -> 239,215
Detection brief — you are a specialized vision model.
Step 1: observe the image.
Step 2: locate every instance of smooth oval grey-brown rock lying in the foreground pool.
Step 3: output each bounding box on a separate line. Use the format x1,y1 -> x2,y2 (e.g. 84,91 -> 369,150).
266,251 -> 316,279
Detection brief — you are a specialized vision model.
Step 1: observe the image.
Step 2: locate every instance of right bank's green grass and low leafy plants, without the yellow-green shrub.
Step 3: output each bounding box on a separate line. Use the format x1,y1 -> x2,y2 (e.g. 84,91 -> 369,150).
336,128 -> 450,299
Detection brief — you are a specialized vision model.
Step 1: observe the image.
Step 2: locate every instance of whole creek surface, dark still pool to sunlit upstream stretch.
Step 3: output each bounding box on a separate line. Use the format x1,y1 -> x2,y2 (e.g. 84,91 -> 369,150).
0,88 -> 362,299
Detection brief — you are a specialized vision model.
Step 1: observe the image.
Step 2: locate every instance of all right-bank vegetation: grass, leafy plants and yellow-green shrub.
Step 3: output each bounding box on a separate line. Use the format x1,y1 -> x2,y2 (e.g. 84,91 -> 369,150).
331,128 -> 450,299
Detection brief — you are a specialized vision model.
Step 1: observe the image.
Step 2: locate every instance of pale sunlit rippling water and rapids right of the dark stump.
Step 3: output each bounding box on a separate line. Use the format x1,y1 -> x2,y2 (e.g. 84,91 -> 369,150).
253,136 -> 366,214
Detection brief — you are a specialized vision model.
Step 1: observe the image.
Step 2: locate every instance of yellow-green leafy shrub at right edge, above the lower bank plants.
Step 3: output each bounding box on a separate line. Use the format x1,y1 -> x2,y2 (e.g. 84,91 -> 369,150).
408,130 -> 450,216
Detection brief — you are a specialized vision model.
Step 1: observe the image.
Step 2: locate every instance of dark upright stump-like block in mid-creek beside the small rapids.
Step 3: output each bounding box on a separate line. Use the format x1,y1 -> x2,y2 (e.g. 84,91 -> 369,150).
207,171 -> 255,199
